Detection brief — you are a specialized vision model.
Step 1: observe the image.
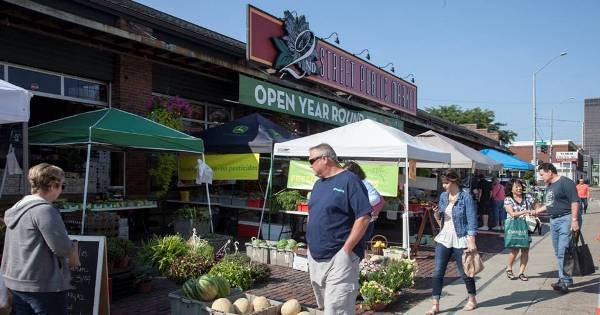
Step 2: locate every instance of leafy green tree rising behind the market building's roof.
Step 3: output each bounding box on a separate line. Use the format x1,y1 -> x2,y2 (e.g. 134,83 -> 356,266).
425,105 -> 517,146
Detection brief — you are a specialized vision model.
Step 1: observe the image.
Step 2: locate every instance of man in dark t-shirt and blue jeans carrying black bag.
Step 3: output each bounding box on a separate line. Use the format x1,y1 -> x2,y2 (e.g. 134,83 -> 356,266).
534,163 -> 581,293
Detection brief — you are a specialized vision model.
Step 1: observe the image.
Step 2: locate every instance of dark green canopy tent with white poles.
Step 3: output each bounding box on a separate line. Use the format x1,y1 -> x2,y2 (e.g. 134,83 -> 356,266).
29,108 -> 206,234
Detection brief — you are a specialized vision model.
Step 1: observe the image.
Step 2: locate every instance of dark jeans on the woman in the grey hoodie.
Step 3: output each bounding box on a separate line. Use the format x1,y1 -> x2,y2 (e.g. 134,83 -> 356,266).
11,290 -> 68,315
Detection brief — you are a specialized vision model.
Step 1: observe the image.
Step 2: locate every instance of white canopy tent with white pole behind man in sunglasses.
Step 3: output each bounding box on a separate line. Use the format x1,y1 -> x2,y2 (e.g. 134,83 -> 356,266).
272,119 -> 450,251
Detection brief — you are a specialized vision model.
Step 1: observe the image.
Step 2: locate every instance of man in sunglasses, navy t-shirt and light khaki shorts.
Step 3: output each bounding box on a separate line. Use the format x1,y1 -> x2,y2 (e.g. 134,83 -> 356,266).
306,143 -> 372,315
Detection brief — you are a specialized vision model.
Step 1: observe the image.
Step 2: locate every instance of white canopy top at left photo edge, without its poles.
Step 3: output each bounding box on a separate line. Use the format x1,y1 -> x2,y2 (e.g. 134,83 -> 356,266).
0,80 -> 33,124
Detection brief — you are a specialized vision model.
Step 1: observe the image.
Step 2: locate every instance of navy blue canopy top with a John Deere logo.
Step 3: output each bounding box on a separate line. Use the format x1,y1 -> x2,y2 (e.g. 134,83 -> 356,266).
200,114 -> 295,153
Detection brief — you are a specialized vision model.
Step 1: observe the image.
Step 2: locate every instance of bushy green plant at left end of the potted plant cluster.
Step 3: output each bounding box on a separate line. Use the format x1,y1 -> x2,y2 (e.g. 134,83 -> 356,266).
140,235 -> 189,274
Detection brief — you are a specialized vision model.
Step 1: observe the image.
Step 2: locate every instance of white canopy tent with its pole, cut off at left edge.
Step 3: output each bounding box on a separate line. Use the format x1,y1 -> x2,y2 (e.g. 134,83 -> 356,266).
0,80 -> 33,197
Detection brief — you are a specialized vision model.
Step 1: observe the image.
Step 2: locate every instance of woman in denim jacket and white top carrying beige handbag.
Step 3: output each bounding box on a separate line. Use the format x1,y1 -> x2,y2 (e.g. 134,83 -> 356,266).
426,171 -> 477,315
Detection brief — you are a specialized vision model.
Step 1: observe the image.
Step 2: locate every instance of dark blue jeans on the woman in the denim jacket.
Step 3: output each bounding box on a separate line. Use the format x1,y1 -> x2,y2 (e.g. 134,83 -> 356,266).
431,243 -> 476,300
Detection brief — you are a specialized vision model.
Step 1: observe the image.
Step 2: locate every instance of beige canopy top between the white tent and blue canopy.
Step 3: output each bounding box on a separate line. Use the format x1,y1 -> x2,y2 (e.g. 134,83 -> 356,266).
416,130 -> 502,171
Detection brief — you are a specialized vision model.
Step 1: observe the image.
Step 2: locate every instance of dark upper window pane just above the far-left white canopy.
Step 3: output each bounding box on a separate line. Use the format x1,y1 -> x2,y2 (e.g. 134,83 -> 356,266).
8,67 -> 61,95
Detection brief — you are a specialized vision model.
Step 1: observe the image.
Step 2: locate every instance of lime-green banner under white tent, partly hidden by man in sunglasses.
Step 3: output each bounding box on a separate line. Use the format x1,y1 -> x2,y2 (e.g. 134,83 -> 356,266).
287,160 -> 398,197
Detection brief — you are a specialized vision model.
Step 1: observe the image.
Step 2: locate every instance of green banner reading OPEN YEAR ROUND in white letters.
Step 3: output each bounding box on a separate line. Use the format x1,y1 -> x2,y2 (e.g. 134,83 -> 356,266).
239,74 -> 404,130
